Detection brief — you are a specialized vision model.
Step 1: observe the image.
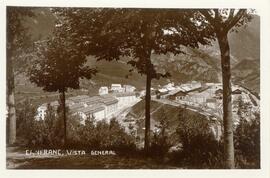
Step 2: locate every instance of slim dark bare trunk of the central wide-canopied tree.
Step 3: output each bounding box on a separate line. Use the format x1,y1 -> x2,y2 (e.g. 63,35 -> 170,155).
144,59 -> 152,155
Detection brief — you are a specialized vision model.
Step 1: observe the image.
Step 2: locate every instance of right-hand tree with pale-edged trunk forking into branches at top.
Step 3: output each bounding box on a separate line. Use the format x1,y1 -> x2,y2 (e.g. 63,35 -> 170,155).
200,9 -> 251,169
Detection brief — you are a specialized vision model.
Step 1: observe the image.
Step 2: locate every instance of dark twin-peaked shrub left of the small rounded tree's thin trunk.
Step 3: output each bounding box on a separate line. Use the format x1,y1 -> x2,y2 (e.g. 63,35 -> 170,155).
17,100 -> 63,147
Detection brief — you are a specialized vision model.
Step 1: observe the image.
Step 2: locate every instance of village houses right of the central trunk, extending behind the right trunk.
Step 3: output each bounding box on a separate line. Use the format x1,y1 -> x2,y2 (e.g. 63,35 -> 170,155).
155,81 -> 254,110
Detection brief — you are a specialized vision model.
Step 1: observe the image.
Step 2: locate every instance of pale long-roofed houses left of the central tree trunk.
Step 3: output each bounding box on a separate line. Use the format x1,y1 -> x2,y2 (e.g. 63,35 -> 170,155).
36,84 -> 139,124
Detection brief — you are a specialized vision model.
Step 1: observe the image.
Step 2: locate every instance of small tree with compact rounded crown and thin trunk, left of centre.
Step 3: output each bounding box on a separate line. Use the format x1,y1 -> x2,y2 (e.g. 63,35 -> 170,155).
29,27 -> 97,145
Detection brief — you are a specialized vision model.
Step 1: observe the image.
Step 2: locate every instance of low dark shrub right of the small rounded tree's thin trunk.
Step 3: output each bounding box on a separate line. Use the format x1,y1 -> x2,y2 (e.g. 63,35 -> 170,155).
71,117 -> 135,152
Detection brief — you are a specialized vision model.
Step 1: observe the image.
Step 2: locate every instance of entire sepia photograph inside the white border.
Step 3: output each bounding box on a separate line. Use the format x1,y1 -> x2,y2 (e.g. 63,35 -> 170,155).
5,3 -> 261,170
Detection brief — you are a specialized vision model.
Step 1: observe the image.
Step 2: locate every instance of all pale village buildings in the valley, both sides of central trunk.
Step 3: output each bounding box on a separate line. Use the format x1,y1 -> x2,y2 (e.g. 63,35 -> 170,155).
36,81 -> 258,126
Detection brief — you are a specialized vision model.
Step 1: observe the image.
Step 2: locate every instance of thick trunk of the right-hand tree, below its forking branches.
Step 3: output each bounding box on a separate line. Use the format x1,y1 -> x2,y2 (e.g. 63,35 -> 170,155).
217,33 -> 234,169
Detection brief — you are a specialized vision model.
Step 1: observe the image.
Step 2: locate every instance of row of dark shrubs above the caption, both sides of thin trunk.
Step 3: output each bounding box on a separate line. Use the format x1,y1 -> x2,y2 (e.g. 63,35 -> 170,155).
17,101 -> 136,152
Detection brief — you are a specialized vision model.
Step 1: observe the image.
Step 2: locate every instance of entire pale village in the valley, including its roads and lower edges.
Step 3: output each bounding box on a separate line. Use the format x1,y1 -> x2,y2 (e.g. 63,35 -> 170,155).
36,81 -> 260,142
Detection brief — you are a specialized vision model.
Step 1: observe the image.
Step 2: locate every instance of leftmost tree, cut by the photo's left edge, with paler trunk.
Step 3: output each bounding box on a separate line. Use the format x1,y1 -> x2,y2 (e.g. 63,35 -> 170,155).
6,7 -> 34,144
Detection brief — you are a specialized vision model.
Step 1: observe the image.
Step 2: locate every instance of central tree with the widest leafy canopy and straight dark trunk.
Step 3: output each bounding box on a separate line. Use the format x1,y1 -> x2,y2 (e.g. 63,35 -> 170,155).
53,8 -> 215,153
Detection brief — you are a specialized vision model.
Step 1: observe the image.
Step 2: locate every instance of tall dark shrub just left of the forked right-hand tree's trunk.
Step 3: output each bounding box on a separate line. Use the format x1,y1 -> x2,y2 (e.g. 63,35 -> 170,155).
172,108 -> 223,168
